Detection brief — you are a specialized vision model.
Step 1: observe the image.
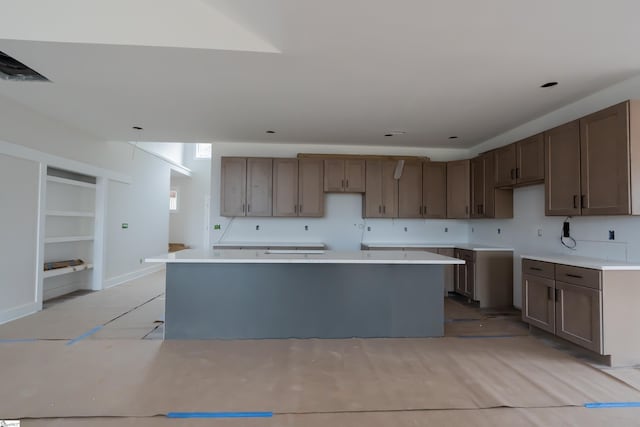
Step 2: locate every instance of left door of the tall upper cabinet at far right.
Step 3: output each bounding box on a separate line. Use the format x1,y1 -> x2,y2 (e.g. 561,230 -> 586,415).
544,120 -> 580,215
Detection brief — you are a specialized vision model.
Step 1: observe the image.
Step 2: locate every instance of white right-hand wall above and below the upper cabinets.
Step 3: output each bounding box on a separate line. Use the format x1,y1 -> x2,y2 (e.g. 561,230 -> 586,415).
470,77 -> 640,307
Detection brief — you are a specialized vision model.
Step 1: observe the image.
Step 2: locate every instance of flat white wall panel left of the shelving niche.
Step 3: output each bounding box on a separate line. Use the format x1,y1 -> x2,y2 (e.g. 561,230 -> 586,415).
0,154 -> 40,323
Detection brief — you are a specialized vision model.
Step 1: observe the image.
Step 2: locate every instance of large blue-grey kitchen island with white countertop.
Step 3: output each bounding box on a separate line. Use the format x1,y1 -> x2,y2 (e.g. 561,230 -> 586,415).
146,250 -> 463,339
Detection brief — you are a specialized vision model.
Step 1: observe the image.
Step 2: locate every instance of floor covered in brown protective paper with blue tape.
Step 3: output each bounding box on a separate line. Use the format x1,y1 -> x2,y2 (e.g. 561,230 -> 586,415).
0,273 -> 640,427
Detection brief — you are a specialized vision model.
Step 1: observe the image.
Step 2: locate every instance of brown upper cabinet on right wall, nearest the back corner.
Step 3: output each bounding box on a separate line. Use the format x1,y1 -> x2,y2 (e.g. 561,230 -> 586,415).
471,151 -> 513,218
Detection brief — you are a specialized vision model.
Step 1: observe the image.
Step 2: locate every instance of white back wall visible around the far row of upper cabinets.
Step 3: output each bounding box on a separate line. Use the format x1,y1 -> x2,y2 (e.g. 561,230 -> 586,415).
211,143 -> 468,250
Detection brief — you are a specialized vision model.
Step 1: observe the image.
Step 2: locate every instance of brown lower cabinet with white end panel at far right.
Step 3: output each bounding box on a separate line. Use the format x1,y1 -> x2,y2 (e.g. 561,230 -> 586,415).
522,258 -> 640,366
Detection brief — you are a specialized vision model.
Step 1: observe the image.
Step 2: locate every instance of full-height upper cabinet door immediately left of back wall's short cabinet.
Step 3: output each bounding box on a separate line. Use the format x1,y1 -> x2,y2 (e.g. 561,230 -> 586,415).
298,159 -> 324,217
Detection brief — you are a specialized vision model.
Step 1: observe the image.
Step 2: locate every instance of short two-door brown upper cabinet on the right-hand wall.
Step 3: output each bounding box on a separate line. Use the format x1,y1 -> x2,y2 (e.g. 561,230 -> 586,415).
495,134 -> 544,187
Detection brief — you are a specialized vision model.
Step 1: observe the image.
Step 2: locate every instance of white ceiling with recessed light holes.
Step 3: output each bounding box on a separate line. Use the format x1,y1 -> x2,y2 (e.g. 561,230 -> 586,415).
0,0 -> 640,147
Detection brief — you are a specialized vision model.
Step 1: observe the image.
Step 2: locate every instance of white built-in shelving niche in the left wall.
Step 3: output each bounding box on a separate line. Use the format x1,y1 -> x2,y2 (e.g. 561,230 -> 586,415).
42,167 -> 96,301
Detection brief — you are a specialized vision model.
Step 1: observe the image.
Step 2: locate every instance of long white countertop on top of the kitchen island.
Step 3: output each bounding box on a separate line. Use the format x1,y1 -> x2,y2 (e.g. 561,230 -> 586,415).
145,249 -> 464,265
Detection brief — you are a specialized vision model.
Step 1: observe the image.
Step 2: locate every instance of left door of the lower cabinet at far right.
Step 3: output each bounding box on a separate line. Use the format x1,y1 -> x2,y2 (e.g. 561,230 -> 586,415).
522,274 -> 556,334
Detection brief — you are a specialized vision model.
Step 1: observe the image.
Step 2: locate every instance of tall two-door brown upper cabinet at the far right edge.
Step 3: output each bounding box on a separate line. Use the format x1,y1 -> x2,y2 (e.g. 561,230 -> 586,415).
545,101 -> 640,215
